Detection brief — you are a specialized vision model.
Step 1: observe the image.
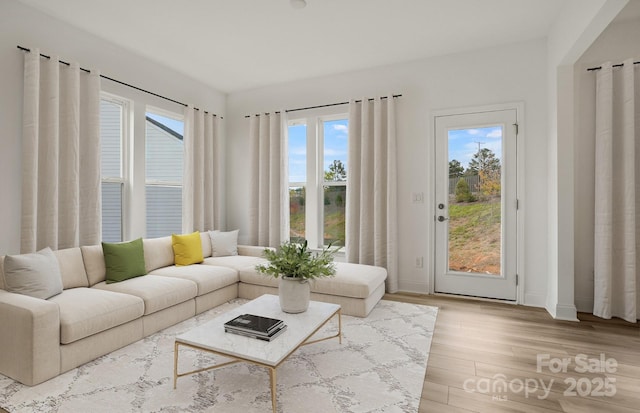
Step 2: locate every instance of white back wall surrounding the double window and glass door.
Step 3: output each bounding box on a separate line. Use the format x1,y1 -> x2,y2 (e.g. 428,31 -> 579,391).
227,39 -> 547,305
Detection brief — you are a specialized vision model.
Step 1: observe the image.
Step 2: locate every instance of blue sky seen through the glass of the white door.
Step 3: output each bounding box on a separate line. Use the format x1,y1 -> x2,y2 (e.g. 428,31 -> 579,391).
449,126 -> 502,169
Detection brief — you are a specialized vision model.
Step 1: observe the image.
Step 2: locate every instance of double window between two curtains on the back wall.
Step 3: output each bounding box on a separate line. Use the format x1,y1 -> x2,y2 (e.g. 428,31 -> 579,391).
288,115 -> 348,248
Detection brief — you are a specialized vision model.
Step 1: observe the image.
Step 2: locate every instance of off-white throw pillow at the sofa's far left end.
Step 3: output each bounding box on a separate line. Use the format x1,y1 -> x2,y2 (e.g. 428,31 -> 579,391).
4,247 -> 62,300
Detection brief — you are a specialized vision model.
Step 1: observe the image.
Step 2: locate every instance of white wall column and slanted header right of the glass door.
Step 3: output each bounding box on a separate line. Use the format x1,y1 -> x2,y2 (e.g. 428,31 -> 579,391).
545,0 -> 628,321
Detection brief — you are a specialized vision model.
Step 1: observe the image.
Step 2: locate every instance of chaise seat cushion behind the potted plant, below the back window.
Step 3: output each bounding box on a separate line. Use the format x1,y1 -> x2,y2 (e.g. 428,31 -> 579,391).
238,262 -> 387,298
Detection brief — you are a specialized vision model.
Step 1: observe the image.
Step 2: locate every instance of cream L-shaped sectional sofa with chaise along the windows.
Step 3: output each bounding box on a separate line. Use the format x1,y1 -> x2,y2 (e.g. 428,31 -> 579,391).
0,232 -> 387,385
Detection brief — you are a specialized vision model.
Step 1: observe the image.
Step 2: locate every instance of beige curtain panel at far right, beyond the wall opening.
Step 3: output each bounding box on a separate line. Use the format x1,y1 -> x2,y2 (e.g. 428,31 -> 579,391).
593,59 -> 640,323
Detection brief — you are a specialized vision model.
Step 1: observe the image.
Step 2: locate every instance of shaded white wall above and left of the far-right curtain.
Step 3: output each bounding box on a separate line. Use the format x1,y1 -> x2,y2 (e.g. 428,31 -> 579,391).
574,19 -> 640,312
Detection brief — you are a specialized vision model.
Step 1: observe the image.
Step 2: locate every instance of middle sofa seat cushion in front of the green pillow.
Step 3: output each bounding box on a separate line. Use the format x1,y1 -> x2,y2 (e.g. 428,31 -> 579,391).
91,275 -> 198,315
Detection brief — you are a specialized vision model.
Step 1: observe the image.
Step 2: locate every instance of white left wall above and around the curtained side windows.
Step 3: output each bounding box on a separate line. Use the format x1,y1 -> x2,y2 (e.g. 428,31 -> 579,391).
0,0 -> 226,255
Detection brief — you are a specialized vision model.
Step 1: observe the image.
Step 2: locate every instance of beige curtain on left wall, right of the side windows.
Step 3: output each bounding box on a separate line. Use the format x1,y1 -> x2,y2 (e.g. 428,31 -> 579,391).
182,106 -> 224,233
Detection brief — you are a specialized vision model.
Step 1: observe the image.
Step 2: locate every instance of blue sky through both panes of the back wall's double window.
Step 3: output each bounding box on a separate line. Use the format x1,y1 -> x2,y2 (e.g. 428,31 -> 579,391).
289,119 -> 349,182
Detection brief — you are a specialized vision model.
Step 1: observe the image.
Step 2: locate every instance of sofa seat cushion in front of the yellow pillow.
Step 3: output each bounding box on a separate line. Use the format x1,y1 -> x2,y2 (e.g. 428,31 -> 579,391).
150,265 -> 238,296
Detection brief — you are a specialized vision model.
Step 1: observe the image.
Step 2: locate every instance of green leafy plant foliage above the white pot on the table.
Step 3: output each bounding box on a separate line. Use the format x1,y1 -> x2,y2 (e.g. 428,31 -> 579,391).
256,240 -> 339,280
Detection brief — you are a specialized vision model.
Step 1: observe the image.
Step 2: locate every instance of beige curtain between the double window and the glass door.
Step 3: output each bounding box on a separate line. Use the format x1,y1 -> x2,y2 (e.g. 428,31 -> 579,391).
346,96 -> 398,292
